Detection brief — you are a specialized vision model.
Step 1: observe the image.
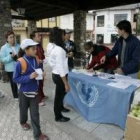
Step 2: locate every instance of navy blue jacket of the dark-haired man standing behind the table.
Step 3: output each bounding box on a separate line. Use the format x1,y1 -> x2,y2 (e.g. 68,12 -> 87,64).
106,35 -> 140,75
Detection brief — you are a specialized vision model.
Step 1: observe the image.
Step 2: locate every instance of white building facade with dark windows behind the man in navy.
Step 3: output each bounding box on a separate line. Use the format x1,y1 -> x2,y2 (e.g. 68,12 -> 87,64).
93,4 -> 137,44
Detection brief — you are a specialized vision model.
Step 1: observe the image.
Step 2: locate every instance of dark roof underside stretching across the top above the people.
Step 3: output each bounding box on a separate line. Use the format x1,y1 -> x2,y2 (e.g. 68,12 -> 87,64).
11,0 -> 139,19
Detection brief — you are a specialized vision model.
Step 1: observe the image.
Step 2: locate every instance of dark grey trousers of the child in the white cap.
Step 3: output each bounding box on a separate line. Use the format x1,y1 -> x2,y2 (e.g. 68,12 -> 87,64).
19,93 -> 41,138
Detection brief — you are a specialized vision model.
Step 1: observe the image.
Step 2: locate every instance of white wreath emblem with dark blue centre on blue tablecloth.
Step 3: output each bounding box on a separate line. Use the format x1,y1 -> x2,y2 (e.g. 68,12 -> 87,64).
75,82 -> 99,107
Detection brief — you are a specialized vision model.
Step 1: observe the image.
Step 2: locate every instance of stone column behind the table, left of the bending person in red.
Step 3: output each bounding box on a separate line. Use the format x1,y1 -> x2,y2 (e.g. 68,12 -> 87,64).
74,10 -> 86,65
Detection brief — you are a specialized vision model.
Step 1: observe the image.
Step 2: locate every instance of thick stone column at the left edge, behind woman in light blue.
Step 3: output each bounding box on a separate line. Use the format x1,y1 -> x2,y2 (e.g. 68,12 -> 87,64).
0,0 -> 12,82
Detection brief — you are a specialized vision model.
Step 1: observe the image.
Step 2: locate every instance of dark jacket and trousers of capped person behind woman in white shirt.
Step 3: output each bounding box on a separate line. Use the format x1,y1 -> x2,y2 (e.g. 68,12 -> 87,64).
64,40 -> 77,68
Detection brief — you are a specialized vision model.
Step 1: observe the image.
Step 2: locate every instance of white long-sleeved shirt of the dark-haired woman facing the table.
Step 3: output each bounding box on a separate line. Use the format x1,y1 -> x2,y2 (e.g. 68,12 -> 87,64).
47,43 -> 69,77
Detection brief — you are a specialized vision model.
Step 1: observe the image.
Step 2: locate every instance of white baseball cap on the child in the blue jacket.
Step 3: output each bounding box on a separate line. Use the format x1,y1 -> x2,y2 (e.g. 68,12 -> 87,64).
20,39 -> 39,50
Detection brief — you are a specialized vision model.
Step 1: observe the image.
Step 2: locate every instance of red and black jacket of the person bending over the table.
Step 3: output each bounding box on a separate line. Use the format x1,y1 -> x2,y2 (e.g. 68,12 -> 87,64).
88,45 -> 118,70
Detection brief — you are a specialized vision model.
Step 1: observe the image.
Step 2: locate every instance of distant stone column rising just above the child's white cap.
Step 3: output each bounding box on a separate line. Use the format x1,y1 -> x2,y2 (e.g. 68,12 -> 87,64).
28,20 -> 37,37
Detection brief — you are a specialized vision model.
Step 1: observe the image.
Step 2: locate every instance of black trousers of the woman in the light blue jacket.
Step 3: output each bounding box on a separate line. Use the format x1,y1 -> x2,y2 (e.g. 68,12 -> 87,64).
7,72 -> 18,98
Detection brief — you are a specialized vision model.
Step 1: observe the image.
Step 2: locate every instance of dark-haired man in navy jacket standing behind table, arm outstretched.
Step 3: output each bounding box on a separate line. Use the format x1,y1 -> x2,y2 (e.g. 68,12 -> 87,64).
100,20 -> 140,79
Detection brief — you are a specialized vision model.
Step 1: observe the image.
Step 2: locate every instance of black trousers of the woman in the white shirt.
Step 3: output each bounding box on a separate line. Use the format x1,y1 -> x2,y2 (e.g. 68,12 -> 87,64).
52,74 -> 66,119
